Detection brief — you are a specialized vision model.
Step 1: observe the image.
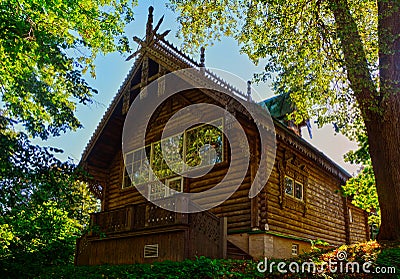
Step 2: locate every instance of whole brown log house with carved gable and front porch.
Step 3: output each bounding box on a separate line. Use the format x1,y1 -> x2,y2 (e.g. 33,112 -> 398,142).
75,8 -> 369,265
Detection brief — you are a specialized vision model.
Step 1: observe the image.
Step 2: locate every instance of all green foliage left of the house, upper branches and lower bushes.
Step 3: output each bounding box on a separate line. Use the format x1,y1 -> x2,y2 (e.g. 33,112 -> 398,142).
0,0 -> 136,277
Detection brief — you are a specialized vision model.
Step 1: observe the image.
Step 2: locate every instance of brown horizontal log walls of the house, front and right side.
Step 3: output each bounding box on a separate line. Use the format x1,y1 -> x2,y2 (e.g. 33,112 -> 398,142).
100,88 -> 366,247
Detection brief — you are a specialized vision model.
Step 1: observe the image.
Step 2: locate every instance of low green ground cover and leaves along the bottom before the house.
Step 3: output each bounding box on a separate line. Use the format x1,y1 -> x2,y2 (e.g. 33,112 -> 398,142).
29,241 -> 400,279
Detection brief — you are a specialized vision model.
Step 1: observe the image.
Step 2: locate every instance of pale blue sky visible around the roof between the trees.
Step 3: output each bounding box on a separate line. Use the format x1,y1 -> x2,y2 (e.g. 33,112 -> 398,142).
35,1 -> 358,173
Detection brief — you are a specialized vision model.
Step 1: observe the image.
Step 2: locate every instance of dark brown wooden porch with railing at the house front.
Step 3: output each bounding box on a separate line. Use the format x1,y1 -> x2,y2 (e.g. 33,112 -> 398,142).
75,196 -> 248,265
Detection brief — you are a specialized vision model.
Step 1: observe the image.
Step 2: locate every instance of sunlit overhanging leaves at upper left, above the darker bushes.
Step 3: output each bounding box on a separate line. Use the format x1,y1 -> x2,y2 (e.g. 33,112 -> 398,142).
0,0 -> 135,139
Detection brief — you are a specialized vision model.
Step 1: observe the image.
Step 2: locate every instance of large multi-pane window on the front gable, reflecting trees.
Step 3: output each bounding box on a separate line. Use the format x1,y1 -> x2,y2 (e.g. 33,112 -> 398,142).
122,118 -> 224,192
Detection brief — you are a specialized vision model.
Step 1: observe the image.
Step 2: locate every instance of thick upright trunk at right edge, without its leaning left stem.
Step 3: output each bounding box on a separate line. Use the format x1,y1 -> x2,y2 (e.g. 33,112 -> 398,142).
374,0 -> 400,241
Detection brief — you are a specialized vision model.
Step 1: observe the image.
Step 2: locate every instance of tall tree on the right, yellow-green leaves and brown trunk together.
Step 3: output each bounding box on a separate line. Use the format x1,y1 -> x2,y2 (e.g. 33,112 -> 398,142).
169,0 -> 400,243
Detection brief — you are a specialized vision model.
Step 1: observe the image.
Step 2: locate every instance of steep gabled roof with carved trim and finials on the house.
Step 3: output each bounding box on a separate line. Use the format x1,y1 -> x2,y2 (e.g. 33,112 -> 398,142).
80,5 -> 350,185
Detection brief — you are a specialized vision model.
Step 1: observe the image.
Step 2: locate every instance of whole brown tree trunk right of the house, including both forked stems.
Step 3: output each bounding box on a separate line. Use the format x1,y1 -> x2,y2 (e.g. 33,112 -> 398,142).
329,0 -> 400,241
